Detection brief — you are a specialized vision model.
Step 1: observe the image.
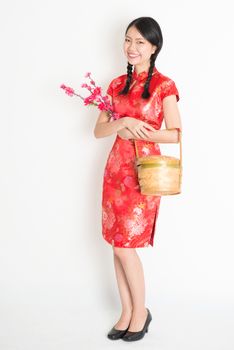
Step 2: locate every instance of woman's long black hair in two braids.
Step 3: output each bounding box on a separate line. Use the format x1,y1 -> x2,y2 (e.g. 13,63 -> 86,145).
119,17 -> 163,99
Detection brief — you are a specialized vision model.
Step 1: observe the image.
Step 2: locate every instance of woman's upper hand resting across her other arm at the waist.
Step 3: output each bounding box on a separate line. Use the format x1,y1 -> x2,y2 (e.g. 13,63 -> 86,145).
123,117 -> 157,139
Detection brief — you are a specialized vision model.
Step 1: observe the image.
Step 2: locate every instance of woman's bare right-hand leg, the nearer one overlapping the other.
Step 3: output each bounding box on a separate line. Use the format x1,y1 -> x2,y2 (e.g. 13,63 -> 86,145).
113,247 -> 147,332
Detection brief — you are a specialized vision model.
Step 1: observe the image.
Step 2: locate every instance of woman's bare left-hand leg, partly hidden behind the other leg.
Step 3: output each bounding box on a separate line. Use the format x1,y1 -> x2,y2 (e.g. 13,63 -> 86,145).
114,250 -> 132,329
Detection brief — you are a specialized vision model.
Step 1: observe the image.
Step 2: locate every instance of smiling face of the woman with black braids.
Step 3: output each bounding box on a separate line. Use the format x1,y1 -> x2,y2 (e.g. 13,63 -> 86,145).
123,26 -> 157,72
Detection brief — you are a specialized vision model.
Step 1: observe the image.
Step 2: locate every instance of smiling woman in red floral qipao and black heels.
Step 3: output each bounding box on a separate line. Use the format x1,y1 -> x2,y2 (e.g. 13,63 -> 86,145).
94,17 -> 182,341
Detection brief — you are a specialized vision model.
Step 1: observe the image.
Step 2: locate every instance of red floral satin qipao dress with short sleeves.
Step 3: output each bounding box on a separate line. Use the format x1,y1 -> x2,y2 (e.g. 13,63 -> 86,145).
102,67 -> 179,248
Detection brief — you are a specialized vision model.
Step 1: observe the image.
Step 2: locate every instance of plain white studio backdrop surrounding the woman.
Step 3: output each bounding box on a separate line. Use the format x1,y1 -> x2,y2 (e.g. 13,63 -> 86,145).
0,0 -> 234,350
